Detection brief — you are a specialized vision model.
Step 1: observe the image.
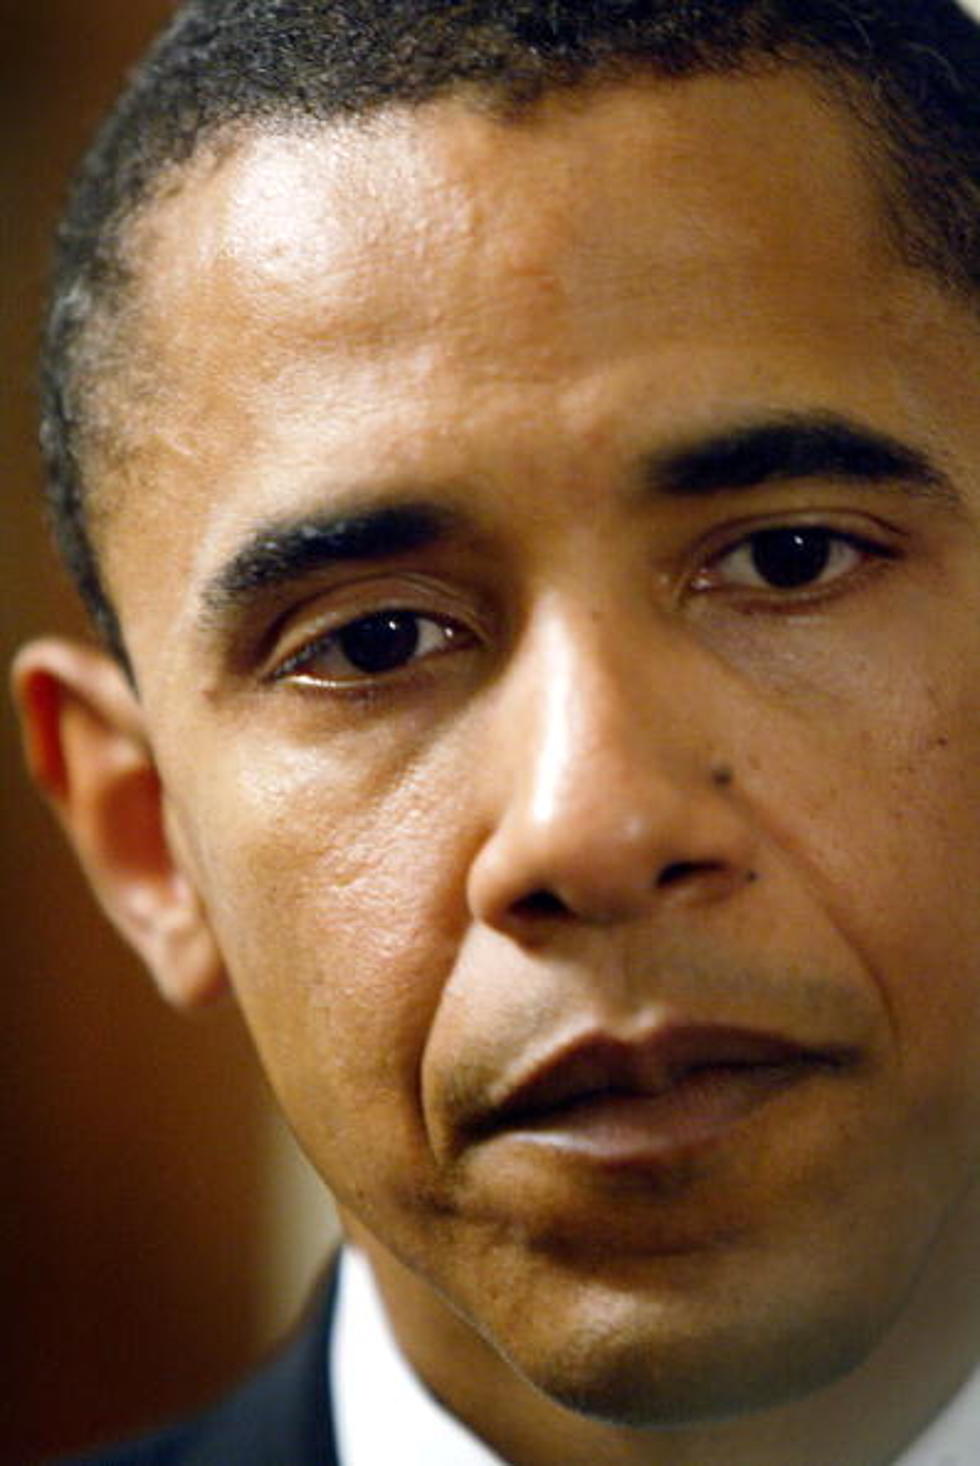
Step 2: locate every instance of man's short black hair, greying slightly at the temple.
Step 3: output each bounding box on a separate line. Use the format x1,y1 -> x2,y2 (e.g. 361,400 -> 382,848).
41,0 -> 980,664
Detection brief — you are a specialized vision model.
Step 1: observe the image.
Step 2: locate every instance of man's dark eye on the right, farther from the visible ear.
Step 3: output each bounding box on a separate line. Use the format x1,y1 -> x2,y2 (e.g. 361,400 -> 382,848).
697,525 -> 889,592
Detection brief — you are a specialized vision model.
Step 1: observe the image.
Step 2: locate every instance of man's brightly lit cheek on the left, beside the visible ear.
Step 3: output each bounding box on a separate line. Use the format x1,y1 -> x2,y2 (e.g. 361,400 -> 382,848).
171,733 -> 475,1189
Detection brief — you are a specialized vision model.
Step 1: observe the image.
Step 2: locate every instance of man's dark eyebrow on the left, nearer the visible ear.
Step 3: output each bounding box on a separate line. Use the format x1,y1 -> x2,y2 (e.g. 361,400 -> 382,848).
201,503 -> 458,626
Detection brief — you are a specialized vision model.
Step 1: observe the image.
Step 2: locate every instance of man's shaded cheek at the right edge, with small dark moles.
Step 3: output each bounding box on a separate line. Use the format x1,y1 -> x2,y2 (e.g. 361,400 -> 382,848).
753,659 -> 980,1155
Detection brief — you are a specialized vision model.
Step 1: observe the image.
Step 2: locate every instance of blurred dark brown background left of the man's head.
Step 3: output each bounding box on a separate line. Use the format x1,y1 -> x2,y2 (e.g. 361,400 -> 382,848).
0,0 -> 333,1466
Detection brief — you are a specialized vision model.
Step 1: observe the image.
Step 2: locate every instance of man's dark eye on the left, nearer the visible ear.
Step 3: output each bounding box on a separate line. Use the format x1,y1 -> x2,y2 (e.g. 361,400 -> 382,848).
276,608 -> 468,686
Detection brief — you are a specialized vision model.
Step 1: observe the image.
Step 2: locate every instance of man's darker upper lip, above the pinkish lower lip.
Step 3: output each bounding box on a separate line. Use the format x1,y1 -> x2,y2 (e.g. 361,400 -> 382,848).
471,1025 -> 851,1135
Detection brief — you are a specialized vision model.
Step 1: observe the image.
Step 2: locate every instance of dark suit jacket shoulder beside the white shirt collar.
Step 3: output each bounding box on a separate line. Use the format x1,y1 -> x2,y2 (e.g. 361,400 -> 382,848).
63,1271 -> 337,1466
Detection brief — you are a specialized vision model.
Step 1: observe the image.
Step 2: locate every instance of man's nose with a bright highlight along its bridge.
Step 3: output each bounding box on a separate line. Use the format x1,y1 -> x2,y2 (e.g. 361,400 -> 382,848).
468,619 -> 756,935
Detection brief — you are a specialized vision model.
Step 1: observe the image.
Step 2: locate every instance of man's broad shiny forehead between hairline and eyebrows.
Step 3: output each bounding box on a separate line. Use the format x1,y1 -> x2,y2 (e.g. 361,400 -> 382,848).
93,72 -> 979,674
